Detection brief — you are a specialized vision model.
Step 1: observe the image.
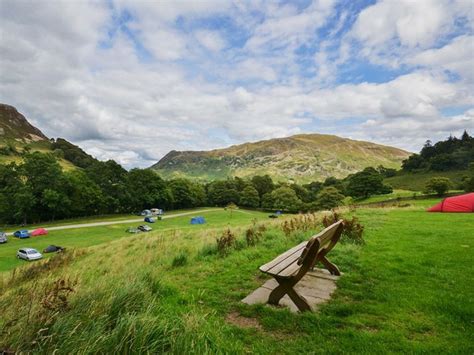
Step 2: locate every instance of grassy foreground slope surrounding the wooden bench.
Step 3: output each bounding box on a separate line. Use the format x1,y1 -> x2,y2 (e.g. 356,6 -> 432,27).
0,199 -> 474,354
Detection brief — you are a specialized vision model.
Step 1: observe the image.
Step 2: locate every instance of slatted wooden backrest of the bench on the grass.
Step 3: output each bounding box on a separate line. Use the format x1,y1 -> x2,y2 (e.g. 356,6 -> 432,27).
298,220 -> 343,266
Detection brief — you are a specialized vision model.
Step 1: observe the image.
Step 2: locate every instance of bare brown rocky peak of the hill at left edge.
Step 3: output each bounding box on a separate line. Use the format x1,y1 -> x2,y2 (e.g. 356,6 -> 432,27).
0,103 -> 48,142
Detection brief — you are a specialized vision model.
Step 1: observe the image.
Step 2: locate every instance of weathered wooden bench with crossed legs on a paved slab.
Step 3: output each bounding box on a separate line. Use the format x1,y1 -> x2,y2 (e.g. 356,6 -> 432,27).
260,220 -> 343,312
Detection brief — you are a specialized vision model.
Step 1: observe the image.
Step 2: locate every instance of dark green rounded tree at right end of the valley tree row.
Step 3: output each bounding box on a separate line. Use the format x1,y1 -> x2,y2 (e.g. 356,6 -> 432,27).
346,168 -> 392,198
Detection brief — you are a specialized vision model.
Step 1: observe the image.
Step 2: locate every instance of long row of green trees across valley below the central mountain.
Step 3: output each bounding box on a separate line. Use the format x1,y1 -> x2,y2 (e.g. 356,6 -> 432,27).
0,151 -> 392,223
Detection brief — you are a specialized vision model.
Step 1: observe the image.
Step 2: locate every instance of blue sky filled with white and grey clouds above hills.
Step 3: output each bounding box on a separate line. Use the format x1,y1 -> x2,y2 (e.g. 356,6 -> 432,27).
0,0 -> 474,168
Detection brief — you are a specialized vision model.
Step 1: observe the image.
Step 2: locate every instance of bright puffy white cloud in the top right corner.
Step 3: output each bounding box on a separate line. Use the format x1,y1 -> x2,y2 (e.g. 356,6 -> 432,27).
348,0 -> 474,67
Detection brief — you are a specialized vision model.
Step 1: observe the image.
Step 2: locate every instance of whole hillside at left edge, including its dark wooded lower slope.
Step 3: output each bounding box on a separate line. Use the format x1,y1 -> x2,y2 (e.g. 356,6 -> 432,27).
0,103 -> 96,169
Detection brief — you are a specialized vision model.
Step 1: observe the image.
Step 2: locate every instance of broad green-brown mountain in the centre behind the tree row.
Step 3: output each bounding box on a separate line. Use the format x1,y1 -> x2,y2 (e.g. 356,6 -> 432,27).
150,134 -> 411,182
